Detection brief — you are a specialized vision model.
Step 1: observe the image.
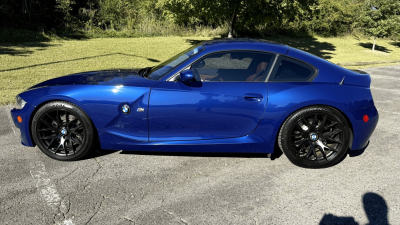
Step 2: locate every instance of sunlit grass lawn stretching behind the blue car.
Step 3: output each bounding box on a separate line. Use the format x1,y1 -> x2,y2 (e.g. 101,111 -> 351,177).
0,37 -> 400,105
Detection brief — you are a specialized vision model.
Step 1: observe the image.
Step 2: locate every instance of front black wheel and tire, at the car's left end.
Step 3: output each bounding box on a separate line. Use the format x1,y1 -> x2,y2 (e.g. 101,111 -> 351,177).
31,101 -> 96,161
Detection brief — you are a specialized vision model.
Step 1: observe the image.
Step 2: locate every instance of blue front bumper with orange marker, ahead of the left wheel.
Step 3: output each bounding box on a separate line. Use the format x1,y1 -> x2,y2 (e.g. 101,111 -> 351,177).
10,103 -> 35,147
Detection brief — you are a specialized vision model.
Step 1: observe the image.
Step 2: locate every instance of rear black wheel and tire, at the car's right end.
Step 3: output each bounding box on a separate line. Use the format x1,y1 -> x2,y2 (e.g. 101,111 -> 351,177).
278,106 -> 350,168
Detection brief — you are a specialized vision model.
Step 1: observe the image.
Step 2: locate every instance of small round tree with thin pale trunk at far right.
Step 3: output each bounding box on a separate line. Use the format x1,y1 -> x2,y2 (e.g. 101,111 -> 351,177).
360,0 -> 400,51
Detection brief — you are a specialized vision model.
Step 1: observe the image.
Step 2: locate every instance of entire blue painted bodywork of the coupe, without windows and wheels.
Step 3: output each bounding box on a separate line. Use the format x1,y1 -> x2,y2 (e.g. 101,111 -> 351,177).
11,39 -> 378,156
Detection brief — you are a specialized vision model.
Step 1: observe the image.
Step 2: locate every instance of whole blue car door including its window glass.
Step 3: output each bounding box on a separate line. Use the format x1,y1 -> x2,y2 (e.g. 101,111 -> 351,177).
148,51 -> 275,141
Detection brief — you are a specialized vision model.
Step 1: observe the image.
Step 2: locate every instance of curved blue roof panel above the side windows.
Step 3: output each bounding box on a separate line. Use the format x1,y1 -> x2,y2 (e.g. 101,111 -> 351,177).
203,38 -> 289,55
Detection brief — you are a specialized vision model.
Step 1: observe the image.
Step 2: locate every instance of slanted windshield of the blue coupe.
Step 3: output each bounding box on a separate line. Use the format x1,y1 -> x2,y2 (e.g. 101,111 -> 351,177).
148,45 -> 203,80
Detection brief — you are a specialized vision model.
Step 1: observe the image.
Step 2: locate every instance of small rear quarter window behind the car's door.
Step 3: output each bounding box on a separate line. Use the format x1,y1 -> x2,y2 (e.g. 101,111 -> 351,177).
269,56 -> 315,82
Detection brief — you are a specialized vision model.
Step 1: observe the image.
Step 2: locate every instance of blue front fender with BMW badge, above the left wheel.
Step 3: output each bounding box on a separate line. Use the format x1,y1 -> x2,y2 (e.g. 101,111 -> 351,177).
20,85 -> 150,145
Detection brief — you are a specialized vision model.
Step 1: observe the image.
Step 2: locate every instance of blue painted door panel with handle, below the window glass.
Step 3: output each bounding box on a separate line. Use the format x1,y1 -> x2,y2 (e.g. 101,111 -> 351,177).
149,82 -> 268,141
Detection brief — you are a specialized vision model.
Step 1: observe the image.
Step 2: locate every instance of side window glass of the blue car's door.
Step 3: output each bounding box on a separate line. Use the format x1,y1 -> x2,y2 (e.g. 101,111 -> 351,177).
190,51 -> 275,82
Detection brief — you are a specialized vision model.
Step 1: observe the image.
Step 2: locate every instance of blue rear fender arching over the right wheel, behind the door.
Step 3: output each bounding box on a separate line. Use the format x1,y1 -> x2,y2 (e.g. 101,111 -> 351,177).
255,82 -> 376,153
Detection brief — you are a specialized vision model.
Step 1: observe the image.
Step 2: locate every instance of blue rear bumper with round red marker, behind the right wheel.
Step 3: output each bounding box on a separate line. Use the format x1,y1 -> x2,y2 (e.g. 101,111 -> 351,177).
346,106 -> 379,150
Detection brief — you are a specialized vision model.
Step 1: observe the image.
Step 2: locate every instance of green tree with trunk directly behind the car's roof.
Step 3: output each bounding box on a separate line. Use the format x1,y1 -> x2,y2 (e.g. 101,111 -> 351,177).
160,0 -> 316,37
